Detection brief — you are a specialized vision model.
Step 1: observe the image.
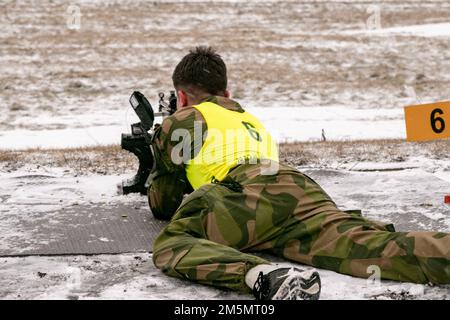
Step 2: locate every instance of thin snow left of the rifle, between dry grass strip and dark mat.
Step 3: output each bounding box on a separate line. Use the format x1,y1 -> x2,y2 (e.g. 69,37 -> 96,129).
0,165 -> 148,254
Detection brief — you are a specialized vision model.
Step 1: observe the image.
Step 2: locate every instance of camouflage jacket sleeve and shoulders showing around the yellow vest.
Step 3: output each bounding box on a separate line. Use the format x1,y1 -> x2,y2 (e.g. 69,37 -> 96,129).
148,96 -> 244,220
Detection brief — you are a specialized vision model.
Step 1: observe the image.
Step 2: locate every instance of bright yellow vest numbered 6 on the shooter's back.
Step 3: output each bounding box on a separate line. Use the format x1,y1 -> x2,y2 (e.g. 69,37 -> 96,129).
185,102 -> 278,190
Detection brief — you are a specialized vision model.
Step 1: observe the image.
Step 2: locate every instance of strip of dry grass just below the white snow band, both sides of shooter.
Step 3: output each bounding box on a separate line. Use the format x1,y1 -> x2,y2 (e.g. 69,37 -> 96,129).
0,140 -> 450,175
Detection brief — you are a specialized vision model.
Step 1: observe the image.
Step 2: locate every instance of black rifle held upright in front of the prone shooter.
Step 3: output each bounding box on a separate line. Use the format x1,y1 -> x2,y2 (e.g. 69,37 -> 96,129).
119,91 -> 177,195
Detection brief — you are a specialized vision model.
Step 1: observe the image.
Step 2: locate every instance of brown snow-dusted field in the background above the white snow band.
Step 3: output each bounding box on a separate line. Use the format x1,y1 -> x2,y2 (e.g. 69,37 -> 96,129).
0,0 -> 450,130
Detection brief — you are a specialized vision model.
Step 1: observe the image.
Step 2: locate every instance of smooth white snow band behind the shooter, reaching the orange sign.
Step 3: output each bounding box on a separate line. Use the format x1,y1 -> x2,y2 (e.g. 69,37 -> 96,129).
0,105 -> 406,150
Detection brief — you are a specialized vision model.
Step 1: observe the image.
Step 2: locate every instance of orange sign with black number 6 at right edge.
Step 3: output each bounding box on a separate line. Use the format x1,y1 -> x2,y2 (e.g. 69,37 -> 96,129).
405,101 -> 450,141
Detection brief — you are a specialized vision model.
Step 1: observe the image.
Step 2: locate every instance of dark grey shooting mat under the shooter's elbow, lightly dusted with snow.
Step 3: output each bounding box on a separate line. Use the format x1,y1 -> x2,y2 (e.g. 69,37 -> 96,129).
0,205 -> 167,256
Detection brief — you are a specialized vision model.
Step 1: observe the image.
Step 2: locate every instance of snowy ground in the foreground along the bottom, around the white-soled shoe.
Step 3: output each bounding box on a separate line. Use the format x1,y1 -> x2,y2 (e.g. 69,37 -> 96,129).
0,254 -> 450,300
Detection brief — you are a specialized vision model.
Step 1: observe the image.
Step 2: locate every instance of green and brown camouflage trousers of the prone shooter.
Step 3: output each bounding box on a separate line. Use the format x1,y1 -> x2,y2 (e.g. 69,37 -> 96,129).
153,165 -> 450,291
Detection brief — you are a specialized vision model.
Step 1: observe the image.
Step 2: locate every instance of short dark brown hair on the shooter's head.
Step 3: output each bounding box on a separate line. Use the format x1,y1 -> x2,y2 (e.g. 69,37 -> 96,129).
172,46 -> 227,95
